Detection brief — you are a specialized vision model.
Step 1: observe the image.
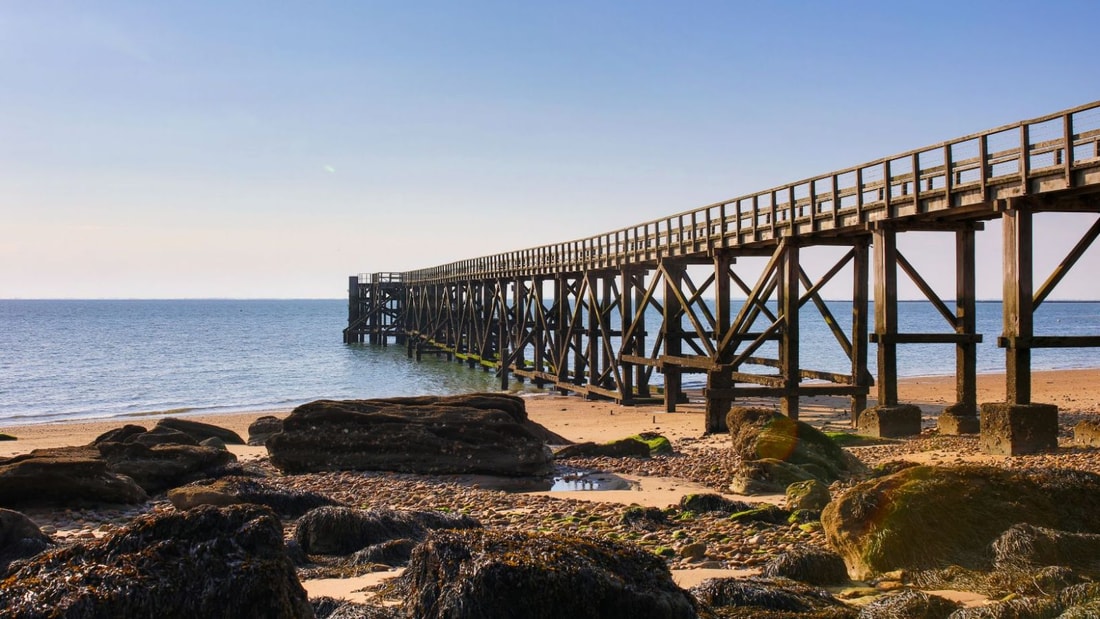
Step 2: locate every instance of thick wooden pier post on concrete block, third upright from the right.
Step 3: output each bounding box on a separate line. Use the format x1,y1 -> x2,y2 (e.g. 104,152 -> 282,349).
871,226 -> 898,406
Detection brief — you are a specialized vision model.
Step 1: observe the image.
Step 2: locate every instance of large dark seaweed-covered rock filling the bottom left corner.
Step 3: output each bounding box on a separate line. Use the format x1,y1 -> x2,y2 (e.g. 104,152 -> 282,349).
0,506 -> 314,618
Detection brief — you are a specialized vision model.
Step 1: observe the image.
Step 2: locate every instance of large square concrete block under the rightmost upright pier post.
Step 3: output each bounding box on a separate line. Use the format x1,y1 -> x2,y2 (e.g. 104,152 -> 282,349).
978,402 -> 1058,455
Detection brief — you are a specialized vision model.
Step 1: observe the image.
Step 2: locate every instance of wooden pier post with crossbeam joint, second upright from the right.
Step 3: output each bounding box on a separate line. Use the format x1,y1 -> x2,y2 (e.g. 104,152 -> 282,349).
955,226 -> 978,414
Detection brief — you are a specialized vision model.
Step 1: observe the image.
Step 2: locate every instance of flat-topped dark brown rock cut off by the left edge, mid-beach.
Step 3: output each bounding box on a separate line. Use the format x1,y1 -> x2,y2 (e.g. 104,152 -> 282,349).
0,447 -> 149,507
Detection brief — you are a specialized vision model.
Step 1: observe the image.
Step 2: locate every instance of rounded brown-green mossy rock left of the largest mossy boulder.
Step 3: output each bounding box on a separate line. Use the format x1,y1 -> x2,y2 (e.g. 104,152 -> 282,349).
726,407 -> 858,494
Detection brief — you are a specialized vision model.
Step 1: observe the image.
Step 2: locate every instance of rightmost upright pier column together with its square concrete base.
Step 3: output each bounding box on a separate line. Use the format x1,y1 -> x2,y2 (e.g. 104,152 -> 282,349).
979,200 -> 1058,455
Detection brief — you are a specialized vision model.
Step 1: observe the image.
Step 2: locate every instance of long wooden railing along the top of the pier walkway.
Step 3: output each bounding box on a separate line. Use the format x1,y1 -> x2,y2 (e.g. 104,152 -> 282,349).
400,101 -> 1100,284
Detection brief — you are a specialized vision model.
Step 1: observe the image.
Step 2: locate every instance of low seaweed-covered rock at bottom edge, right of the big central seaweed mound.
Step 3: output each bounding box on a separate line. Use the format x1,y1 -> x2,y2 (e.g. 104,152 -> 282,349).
691,577 -> 857,619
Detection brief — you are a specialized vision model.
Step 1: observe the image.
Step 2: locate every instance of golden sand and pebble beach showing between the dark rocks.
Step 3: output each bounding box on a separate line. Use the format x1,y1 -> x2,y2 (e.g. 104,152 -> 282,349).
0,369 -> 1100,604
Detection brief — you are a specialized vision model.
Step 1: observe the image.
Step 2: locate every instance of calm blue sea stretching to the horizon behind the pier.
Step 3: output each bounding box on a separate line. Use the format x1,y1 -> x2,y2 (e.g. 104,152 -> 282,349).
0,299 -> 1100,430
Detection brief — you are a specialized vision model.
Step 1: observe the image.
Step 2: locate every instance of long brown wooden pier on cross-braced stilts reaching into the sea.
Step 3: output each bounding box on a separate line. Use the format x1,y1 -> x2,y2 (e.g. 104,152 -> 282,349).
344,101 -> 1100,453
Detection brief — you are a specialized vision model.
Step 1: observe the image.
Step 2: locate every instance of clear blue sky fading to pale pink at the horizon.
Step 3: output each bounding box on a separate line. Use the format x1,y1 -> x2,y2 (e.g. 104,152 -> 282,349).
0,0 -> 1100,299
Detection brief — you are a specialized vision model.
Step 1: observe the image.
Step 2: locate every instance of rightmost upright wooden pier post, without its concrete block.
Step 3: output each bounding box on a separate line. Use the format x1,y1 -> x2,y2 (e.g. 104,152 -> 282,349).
1001,200 -> 1034,405
